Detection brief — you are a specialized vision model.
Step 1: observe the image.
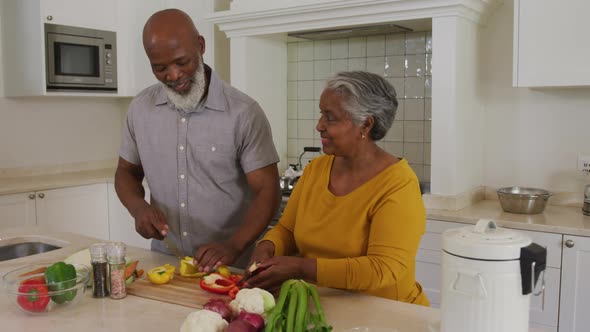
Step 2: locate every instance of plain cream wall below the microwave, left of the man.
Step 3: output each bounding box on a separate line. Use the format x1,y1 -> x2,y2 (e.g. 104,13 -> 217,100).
0,13 -> 128,169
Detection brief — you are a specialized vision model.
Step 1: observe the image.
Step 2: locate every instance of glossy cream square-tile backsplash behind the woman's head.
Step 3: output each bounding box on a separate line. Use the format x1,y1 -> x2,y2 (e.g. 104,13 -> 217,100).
287,31 -> 432,182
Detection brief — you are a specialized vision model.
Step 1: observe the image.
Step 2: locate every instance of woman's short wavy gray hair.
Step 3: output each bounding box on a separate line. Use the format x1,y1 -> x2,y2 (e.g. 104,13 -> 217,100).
325,71 -> 398,141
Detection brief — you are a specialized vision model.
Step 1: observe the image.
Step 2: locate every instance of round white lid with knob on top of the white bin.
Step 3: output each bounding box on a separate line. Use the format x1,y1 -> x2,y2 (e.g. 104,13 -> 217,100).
442,219 -> 532,261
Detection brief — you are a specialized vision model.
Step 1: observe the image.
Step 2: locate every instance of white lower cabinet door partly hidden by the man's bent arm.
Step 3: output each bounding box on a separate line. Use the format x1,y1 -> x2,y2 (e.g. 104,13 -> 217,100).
108,183 -> 151,249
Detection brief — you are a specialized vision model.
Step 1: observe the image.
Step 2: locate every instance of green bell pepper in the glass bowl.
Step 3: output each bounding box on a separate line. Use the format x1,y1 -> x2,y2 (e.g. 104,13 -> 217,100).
45,262 -> 77,304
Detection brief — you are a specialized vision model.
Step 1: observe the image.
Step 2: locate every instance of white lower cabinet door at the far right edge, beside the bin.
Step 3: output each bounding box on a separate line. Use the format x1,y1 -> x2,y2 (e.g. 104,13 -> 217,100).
559,235 -> 590,332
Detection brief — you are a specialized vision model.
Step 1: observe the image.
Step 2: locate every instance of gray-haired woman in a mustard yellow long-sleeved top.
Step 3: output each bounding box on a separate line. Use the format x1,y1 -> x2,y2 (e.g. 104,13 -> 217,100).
248,71 -> 429,305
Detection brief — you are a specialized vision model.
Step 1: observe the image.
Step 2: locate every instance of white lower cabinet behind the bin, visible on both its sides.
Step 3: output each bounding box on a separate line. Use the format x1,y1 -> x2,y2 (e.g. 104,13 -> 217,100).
416,220 -> 562,332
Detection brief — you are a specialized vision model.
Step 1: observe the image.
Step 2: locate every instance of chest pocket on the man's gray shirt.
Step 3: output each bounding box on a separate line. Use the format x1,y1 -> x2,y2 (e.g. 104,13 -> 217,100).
193,143 -> 241,184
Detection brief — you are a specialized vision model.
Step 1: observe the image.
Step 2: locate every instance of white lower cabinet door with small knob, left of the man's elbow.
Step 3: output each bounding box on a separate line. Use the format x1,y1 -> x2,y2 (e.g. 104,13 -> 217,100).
36,183 -> 109,240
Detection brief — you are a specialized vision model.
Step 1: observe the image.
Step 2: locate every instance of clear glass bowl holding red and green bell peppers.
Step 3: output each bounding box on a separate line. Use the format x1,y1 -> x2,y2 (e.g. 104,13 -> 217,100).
2,263 -> 90,314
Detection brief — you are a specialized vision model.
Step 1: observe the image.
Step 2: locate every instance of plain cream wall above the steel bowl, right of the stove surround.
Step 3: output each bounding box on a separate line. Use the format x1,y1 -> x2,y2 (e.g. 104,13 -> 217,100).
480,0 -> 590,192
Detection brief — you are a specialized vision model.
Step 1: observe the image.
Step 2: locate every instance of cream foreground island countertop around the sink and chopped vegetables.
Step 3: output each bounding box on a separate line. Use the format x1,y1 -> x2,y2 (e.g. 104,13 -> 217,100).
0,228 -> 538,332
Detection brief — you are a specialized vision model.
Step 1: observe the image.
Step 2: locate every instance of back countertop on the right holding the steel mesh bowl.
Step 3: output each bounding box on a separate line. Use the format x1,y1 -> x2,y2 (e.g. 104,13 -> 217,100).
427,200 -> 590,236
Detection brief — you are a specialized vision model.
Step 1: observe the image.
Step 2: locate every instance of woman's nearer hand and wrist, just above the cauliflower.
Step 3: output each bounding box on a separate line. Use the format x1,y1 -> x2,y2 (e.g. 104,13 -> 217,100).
246,256 -> 317,293
